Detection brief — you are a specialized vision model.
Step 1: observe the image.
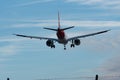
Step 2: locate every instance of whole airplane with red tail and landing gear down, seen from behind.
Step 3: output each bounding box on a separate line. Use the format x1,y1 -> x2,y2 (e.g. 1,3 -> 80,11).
13,12 -> 110,50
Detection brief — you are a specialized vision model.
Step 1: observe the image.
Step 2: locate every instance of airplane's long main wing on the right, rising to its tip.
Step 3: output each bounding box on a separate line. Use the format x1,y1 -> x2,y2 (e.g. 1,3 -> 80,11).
68,30 -> 110,41
